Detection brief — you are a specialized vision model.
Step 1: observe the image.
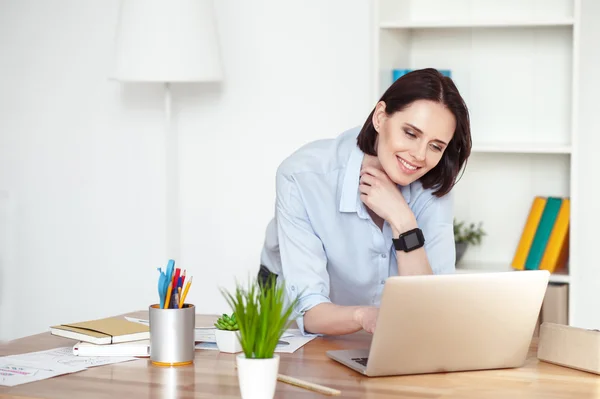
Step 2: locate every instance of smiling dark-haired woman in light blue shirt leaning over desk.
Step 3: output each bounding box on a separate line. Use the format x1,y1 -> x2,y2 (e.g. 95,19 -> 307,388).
259,69 -> 471,335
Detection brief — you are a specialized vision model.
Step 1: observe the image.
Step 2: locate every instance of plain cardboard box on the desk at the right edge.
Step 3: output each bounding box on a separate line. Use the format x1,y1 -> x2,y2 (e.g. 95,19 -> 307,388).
537,322 -> 600,374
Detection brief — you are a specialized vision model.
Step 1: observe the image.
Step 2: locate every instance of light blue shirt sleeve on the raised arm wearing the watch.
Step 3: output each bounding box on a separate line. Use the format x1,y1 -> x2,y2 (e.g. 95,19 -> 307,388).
417,191 -> 456,274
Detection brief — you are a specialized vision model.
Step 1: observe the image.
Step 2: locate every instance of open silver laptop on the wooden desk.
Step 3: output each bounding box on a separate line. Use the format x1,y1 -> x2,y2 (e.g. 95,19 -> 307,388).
326,270 -> 550,377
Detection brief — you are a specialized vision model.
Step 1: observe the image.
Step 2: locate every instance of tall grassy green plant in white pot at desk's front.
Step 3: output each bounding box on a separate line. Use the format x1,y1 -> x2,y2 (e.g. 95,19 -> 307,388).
222,275 -> 297,399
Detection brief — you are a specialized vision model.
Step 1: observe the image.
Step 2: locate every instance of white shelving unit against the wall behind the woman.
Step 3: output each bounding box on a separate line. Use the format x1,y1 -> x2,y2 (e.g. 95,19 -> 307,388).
372,0 -> 600,328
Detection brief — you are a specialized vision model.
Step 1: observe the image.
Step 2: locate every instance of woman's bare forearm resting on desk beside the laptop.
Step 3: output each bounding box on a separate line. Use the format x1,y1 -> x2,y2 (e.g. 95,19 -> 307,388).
304,303 -> 362,335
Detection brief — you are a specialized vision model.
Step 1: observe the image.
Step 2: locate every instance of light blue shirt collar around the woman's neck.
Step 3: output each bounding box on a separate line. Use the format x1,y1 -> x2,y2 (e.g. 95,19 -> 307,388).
339,146 -> 410,219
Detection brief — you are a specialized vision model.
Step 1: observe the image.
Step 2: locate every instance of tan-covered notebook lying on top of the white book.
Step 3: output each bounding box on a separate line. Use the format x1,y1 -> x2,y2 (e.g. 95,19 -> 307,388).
50,317 -> 150,345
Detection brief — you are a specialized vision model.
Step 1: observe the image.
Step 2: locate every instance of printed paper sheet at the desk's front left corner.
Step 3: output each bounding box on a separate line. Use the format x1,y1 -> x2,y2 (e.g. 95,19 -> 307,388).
0,346 -> 137,386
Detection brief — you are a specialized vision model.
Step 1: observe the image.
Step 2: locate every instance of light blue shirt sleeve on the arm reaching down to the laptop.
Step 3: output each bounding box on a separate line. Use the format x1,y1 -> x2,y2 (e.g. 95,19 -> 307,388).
276,174 -> 331,335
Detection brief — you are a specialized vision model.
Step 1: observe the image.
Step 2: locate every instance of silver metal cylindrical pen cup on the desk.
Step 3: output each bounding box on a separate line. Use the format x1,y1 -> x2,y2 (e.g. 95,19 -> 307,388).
149,303 -> 196,367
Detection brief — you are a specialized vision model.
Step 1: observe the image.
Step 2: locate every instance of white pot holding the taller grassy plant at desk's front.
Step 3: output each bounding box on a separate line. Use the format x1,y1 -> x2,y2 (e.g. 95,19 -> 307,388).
236,353 -> 279,399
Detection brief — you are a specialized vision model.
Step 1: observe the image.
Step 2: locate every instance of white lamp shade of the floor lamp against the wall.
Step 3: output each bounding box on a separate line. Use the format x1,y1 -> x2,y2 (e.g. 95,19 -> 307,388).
112,0 -> 222,82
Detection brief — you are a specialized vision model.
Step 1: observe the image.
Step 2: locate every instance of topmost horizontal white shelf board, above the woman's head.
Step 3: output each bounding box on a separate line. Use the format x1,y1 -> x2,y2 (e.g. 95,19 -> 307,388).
379,18 -> 573,29
